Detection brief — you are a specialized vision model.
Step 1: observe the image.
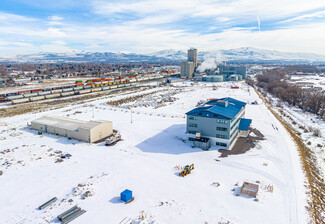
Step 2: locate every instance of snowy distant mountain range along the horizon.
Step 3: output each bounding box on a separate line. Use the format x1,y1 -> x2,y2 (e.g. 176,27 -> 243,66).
0,47 -> 325,63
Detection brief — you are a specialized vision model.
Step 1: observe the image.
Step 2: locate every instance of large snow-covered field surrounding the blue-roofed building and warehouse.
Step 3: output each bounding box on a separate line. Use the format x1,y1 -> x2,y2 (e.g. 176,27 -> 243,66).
0,83 -> 308,224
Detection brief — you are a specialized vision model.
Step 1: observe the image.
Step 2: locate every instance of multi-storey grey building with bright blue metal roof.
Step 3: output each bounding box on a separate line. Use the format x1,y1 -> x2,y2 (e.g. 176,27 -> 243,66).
186,97 -> 252,149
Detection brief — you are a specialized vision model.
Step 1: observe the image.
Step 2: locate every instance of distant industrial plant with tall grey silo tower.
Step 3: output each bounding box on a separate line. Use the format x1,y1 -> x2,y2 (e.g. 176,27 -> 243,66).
181,48 -> 246,82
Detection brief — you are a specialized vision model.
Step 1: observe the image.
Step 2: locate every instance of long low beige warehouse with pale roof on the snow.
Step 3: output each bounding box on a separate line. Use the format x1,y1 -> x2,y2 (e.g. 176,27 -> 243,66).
31,116 -> 113,142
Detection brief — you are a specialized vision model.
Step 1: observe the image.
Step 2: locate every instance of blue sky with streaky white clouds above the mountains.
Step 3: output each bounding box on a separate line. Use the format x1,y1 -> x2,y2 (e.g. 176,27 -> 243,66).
0,0 -> 325,55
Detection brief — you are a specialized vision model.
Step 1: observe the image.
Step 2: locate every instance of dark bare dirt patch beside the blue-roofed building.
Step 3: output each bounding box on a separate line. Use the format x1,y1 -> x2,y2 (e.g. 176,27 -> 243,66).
219,128 -> 264,157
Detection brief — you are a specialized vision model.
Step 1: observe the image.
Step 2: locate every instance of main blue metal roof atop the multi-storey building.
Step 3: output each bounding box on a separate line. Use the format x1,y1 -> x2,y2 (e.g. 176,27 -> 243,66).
186,97 -> 246,119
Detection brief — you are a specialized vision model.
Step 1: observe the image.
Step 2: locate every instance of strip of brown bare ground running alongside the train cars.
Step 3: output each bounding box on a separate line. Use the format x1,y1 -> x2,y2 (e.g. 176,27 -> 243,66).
0,87 -> 149,118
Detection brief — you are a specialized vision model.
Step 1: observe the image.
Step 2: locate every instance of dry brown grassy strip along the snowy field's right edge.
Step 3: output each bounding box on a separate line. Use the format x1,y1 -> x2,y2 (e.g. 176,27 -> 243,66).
255,89 -> 325,224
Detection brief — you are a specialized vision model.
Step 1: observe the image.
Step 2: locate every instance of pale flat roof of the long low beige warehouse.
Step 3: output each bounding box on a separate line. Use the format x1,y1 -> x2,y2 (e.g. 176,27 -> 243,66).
32,116 -> 109,130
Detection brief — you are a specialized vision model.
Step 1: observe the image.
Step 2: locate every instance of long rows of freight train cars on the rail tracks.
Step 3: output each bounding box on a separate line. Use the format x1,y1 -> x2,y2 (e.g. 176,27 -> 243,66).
0,75 -> 164,104
